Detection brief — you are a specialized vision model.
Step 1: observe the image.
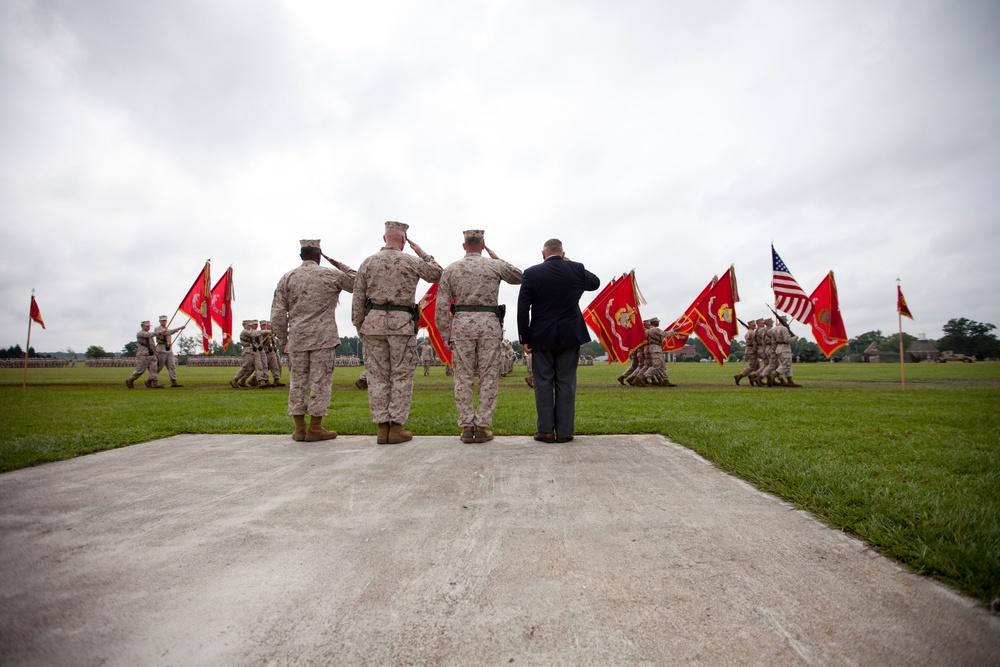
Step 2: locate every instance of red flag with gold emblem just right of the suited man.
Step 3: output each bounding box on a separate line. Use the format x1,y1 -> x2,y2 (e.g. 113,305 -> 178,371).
583,271 -> 646,362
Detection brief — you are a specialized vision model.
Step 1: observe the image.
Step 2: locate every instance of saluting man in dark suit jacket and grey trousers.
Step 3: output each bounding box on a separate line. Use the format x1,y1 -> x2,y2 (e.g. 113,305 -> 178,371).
517,239 -> 601,442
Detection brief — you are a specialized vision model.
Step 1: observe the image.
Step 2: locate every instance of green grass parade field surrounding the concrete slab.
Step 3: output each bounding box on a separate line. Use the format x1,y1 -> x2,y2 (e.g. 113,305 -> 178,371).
0,362 -> 1000,603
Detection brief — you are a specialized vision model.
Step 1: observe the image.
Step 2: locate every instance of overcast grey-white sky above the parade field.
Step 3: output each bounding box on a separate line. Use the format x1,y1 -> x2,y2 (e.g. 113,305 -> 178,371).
0,0 -> 1000,352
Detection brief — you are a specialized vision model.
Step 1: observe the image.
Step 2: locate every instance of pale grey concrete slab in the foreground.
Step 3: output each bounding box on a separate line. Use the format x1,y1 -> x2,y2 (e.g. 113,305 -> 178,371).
0,435 -> 1000,665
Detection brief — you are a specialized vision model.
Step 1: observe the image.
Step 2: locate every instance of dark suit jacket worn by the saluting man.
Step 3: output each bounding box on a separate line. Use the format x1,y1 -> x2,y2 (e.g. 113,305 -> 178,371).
517,255 -> 601,350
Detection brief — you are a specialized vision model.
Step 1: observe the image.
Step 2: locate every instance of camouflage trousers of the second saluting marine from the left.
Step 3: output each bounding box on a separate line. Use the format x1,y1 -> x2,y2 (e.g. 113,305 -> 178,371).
362,335 -> 417,424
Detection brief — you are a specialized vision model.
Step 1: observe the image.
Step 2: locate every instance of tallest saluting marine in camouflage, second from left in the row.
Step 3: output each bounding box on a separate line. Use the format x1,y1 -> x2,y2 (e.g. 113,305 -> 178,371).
351,221 -> 441,445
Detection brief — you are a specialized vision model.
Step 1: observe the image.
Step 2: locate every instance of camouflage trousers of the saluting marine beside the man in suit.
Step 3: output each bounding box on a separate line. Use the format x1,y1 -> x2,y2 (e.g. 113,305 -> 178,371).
451,338 -> 501,428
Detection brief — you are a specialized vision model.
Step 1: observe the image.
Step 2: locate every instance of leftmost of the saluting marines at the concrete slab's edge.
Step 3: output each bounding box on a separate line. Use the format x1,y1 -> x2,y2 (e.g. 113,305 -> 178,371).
271,239 -> 357,442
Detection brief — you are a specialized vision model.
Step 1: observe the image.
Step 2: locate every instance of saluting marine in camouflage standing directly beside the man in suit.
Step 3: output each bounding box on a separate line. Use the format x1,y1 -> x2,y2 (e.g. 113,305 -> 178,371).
435,229 -> 521,442
